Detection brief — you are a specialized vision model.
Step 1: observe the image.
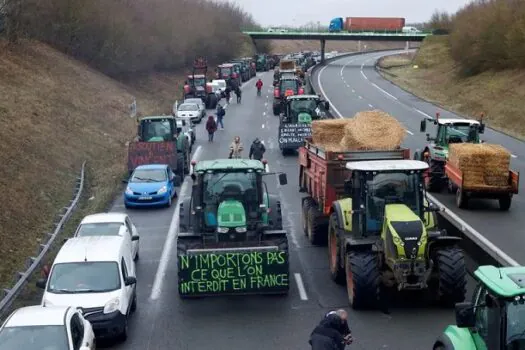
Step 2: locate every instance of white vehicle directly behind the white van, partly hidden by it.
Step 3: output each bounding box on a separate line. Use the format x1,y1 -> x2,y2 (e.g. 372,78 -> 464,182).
73,213 -> 140,261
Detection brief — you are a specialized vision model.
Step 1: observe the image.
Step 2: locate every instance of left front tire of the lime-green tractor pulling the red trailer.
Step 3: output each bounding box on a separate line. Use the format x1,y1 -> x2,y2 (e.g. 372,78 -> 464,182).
345,252 -> 381,310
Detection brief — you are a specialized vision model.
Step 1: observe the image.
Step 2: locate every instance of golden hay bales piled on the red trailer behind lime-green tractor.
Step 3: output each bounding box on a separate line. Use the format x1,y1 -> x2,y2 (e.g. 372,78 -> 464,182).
312,110 -> 406,152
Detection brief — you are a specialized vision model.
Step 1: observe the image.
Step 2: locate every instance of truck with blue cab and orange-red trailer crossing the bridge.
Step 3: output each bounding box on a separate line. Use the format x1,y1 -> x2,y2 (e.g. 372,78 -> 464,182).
328,17 -> 405,33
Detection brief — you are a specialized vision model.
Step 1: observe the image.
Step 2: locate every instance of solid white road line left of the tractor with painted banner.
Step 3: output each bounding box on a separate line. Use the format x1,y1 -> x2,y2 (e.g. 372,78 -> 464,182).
149,146 -> 202,300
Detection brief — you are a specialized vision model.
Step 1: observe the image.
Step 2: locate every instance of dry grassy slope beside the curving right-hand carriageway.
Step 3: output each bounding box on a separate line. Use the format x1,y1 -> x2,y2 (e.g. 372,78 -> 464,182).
374,36 -> 525,139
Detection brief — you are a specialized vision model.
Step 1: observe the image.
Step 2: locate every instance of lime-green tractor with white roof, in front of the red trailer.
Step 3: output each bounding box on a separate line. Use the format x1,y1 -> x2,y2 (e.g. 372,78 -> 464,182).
328,160 -> 466,309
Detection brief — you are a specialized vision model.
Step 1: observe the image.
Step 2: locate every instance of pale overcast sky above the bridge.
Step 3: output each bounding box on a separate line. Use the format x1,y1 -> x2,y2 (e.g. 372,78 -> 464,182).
230,0 -> 470,27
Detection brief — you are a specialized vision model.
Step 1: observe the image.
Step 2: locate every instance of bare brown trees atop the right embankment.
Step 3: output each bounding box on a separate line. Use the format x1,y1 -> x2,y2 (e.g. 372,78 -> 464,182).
430,0 -> 525,75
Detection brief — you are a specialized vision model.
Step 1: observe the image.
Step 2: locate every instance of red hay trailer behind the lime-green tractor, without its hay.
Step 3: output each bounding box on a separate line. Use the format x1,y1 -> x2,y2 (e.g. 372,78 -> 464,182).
299,138 -> 410,245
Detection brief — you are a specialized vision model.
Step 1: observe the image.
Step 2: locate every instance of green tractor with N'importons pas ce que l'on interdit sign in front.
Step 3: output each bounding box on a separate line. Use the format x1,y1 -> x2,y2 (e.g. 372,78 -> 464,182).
177,159 -> 289,298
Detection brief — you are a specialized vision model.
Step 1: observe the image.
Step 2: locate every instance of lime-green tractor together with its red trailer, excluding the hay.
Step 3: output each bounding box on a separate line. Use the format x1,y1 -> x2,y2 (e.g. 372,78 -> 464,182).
299,139 -> 466,309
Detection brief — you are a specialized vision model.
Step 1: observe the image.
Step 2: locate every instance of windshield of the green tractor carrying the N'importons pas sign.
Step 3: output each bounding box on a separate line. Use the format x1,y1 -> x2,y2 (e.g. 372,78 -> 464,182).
202,172 -> 259,226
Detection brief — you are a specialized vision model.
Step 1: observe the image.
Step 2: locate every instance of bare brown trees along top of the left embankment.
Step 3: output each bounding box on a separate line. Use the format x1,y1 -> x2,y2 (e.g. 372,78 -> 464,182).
0,0 -> 268,76
